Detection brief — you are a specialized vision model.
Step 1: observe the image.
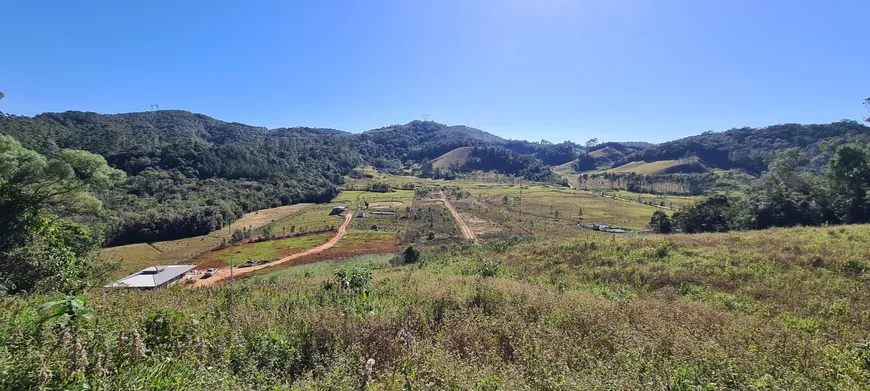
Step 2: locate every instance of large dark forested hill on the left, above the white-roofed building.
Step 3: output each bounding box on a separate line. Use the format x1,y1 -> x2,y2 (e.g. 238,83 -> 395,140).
0,110 -> 363,244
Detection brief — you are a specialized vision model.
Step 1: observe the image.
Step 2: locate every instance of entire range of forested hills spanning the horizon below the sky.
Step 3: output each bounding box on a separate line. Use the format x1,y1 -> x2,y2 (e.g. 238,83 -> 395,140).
0,110 -> 870,244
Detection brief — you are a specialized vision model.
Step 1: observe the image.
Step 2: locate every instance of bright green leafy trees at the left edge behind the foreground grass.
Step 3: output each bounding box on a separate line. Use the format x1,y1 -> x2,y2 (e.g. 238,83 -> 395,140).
0,135 -> 125,293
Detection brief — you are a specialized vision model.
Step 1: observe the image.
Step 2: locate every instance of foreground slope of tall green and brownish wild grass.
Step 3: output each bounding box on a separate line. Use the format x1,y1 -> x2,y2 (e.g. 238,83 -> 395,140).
0,226 -> 870,391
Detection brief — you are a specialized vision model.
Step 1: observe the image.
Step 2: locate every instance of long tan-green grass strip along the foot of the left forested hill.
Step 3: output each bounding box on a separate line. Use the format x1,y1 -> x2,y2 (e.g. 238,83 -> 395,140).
101,204 -> 311,277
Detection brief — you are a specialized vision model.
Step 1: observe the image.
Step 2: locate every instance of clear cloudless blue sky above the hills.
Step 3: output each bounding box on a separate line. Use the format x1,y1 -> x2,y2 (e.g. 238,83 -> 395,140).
0,0 -> 870,142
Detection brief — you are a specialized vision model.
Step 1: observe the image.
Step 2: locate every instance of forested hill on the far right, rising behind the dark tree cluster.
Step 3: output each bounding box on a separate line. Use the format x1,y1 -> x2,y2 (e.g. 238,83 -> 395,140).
614,120 -> 870,173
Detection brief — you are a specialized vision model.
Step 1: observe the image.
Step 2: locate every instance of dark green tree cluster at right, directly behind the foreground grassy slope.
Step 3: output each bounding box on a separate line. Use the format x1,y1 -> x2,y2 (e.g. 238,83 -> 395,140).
650,144 -> 870,233
